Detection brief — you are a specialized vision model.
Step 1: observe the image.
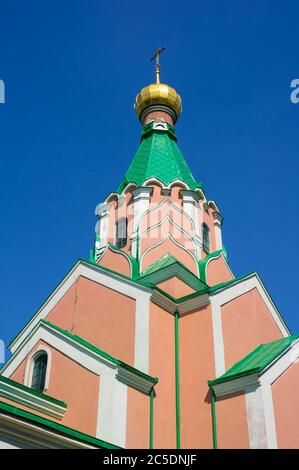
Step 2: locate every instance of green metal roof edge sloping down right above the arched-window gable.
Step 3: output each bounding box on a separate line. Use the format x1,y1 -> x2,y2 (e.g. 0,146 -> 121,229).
39,320 -> 158,384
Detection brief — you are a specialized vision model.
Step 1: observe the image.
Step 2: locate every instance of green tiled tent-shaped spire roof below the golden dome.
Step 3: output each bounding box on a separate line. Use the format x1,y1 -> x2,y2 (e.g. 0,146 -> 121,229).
118,123 -> 203,192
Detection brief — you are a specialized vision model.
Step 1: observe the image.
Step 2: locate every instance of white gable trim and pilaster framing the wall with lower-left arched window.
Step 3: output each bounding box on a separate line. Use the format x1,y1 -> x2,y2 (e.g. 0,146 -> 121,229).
2,323 -> 155,447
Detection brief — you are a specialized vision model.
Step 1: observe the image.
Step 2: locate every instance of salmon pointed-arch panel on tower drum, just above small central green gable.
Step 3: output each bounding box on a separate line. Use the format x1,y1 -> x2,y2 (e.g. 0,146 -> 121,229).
141,239 -> 198,276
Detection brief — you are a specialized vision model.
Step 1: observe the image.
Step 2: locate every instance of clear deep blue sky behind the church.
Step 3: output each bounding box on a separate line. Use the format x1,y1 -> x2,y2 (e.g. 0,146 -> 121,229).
0,0 -> 299,360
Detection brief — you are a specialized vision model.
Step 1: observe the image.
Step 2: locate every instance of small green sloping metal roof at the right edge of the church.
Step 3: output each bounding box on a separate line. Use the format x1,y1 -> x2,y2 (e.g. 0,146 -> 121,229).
209,334 -> 299,385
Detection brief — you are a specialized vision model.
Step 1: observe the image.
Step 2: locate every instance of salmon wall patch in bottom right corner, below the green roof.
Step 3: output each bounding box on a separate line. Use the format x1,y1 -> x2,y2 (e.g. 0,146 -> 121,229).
272,360 -> 299,449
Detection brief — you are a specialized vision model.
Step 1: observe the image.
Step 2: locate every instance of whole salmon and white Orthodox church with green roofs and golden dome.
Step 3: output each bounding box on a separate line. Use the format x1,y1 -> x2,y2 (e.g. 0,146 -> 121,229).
0,57 -> 299,449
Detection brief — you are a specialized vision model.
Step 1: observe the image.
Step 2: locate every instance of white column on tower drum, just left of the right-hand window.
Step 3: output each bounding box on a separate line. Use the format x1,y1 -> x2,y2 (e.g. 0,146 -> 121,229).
180,190 -> 202,259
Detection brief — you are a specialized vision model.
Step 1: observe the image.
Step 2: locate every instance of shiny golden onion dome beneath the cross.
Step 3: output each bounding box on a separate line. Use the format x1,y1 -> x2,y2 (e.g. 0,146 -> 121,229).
134,83 -> 182,121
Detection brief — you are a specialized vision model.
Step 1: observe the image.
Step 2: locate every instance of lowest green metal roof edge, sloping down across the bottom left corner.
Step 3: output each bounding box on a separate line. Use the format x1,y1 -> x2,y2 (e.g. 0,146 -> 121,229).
0,400 -> 121,449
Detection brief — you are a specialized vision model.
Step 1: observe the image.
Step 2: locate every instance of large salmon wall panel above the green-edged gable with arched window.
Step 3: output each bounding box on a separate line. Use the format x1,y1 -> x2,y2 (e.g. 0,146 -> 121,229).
46,276 -> 135,365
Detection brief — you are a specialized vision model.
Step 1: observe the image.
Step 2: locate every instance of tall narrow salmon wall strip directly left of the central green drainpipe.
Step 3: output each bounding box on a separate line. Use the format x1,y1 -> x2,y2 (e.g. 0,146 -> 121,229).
149,303 -> 176,449
